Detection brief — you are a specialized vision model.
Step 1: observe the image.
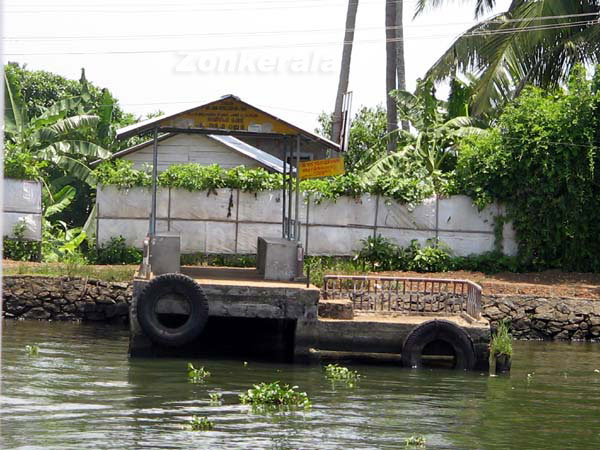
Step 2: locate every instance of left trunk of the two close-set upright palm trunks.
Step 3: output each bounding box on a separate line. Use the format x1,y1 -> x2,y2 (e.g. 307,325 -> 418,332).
385,0 -> 398,152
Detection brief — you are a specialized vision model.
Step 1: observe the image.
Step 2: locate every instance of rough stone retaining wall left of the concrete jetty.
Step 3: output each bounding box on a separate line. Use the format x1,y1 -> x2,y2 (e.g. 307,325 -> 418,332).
2,275 -> 132,322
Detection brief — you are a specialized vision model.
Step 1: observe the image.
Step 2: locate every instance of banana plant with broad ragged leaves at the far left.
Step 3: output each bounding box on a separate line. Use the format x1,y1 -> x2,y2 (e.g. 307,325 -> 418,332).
4,73 -> 111,184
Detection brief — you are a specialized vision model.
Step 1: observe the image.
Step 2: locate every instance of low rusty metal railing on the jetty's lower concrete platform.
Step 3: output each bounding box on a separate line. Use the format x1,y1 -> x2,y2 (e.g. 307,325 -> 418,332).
321,275 -> 481,320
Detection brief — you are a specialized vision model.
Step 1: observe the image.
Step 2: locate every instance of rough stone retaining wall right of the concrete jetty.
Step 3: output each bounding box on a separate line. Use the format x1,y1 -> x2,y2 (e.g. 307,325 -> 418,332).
483,295 -> 600,341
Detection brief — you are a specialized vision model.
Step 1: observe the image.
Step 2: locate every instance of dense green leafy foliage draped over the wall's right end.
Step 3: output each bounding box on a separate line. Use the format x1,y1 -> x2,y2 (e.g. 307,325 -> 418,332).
456,68 -> 600,271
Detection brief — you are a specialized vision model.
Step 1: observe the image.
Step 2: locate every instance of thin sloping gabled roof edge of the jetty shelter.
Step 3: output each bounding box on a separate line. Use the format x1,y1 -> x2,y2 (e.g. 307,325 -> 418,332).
117,95 -> 340,151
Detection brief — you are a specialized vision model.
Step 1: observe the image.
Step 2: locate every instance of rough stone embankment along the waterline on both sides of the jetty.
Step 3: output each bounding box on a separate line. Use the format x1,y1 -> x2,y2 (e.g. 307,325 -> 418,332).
3,275 -> 600,340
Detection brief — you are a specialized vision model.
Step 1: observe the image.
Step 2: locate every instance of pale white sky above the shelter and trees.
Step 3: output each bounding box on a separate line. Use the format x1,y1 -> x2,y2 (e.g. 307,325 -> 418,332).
2,0 -> 510,130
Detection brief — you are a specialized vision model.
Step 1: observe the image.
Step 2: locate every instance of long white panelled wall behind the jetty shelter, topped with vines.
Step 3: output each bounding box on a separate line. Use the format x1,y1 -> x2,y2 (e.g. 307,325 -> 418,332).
97,186 -> 517,256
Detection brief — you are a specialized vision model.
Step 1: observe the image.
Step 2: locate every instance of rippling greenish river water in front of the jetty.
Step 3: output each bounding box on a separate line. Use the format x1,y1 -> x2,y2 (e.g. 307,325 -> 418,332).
0,321 -> 600,449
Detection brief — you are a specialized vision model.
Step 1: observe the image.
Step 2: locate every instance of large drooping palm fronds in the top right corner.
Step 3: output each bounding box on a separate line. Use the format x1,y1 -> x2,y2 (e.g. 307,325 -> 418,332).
415,0 -> 600,115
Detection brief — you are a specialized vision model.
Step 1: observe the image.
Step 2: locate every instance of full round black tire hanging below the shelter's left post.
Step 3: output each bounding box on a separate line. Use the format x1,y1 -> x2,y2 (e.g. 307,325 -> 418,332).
137,273 -> 208,347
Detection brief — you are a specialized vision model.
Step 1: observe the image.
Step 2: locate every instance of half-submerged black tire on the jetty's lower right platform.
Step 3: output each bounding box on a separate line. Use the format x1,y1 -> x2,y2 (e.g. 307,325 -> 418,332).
402,320 -> 476,370
